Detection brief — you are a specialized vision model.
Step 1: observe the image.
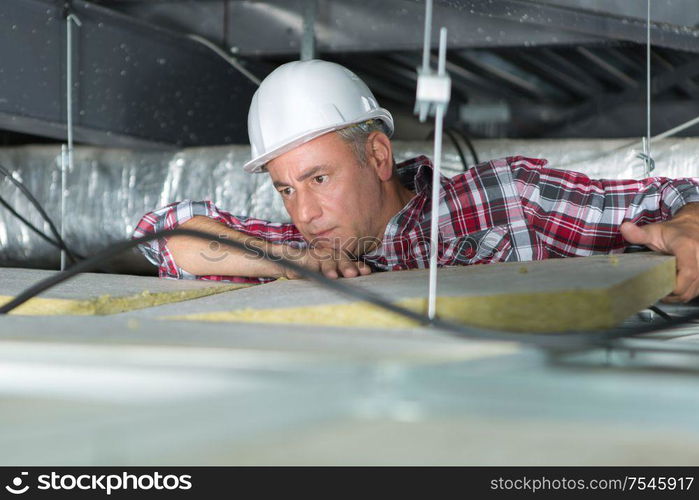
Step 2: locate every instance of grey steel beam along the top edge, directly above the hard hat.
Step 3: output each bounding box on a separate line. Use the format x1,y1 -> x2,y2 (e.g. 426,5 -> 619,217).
90,0 -> 596,57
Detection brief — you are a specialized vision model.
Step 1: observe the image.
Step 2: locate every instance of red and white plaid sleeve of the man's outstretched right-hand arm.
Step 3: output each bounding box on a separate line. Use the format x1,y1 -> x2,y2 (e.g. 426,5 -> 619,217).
508,157 -> 699,256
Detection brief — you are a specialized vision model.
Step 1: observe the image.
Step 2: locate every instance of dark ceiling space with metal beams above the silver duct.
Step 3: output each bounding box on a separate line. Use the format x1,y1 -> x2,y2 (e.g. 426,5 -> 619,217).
0,0 -> 699,146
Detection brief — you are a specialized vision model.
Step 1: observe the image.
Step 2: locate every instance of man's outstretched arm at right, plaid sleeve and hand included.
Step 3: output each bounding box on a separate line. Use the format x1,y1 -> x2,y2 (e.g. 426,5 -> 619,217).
508,157 -> 699,302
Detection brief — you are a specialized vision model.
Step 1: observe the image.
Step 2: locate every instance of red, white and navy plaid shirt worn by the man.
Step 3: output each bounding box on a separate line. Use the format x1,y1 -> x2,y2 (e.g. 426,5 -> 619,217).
134,156 -> 699,283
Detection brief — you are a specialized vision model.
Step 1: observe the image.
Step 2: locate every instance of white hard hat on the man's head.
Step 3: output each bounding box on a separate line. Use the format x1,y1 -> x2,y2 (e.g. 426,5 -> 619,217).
244,60 -> 393,173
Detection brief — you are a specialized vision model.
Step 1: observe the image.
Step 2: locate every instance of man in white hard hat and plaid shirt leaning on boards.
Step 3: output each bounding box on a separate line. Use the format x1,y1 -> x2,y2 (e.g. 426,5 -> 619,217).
134,60 -> 699,301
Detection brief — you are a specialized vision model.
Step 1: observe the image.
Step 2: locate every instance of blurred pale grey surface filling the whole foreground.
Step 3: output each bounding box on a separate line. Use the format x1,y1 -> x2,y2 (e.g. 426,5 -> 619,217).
0,266 -> 699,465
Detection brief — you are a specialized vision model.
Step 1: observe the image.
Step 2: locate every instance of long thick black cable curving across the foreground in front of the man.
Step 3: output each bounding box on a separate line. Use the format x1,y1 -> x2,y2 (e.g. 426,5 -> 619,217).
0,229 -> 699,351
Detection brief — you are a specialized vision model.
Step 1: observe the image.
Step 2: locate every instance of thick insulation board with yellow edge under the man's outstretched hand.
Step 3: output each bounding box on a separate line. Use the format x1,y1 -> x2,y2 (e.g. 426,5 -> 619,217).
160,253 -> 676,332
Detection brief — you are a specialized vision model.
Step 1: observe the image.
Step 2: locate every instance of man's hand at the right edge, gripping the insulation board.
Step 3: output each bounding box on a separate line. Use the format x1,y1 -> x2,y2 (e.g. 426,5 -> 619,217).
621,203 -> 699,302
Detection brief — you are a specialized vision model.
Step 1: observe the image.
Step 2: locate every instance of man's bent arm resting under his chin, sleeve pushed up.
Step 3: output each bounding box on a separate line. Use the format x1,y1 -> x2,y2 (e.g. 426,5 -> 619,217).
134,201 -> 371,283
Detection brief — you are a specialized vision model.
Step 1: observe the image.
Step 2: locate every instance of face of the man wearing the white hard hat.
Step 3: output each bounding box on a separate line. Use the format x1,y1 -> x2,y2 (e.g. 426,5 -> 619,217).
267,132 -> 383,254
